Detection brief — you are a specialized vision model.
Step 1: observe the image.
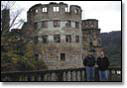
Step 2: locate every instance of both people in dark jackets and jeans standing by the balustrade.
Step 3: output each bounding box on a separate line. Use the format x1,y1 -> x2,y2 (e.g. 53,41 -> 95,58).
83,52 -> 109,81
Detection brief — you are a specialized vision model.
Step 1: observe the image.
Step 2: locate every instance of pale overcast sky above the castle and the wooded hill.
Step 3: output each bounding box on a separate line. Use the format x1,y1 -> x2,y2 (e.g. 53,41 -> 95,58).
13,1 -> 121,32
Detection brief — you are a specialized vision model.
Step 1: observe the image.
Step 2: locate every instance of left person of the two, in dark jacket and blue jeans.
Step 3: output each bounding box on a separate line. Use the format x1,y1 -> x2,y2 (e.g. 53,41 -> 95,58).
83,53 -> 95,81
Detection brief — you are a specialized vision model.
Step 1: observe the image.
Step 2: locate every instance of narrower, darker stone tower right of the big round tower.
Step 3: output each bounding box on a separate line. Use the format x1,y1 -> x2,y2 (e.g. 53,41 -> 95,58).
82,19 -> 101,56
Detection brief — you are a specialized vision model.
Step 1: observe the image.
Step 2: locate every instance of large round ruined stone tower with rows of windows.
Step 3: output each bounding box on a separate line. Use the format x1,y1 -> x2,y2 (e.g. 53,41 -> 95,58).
23,2 -> 82,69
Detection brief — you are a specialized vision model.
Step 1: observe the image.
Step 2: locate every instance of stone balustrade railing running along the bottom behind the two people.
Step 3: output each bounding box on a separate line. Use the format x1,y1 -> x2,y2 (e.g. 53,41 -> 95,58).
1,67 -> 122,82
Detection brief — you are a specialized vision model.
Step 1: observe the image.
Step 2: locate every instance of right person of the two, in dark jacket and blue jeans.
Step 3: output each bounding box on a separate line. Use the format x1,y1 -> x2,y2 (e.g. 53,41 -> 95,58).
97,52 -> 109,81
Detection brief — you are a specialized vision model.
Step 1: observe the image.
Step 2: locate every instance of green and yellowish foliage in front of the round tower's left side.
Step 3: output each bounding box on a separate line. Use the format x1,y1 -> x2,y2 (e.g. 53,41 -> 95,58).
1,32 -> 47,71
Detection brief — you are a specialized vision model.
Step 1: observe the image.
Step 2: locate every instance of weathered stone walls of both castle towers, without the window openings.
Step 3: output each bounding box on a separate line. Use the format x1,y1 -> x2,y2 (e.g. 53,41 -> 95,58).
23,3 -> 100,70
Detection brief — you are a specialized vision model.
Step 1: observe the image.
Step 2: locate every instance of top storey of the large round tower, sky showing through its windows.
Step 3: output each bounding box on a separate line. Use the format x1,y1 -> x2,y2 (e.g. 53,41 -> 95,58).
27,2 -> 82,21
